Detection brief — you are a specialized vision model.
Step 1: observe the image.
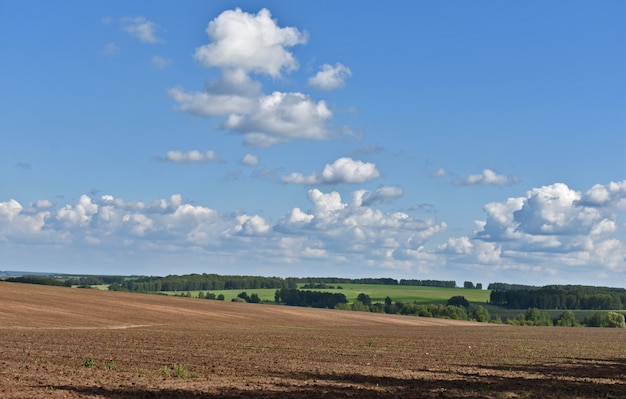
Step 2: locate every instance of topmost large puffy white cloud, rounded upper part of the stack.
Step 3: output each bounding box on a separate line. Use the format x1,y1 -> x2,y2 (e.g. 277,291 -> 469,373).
194,8 -> 307,78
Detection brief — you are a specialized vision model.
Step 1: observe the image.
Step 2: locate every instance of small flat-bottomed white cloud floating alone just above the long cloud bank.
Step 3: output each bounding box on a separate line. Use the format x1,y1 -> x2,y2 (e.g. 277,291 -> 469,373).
281,158 -> 380,184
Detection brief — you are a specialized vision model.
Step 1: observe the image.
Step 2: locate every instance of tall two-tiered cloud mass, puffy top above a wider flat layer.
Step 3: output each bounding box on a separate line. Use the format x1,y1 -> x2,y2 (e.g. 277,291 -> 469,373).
167,8 -> 344,148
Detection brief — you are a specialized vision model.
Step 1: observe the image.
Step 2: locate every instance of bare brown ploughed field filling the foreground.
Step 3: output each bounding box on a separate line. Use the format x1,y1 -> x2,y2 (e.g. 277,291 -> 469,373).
0,282 -> 626,399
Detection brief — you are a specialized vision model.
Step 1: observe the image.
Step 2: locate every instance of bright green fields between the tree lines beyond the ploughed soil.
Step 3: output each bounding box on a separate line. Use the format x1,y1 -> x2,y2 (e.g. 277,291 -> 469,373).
158,284 -> 491,305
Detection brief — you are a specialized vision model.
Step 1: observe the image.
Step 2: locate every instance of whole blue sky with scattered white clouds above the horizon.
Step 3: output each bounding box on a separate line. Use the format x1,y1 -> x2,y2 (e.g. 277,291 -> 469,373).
0,0 -> 626,287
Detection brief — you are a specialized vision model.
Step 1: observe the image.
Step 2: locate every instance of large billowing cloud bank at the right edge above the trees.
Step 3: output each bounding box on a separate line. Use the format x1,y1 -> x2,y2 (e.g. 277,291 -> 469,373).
438,181 -> 626,273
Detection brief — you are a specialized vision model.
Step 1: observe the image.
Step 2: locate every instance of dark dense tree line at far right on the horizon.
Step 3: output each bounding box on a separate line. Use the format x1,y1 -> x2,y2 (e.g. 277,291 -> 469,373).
489,285 -> 626,310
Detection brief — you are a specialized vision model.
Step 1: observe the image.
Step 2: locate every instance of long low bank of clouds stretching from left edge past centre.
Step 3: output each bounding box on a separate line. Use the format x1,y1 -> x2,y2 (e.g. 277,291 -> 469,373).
0,189 -> 448,274
